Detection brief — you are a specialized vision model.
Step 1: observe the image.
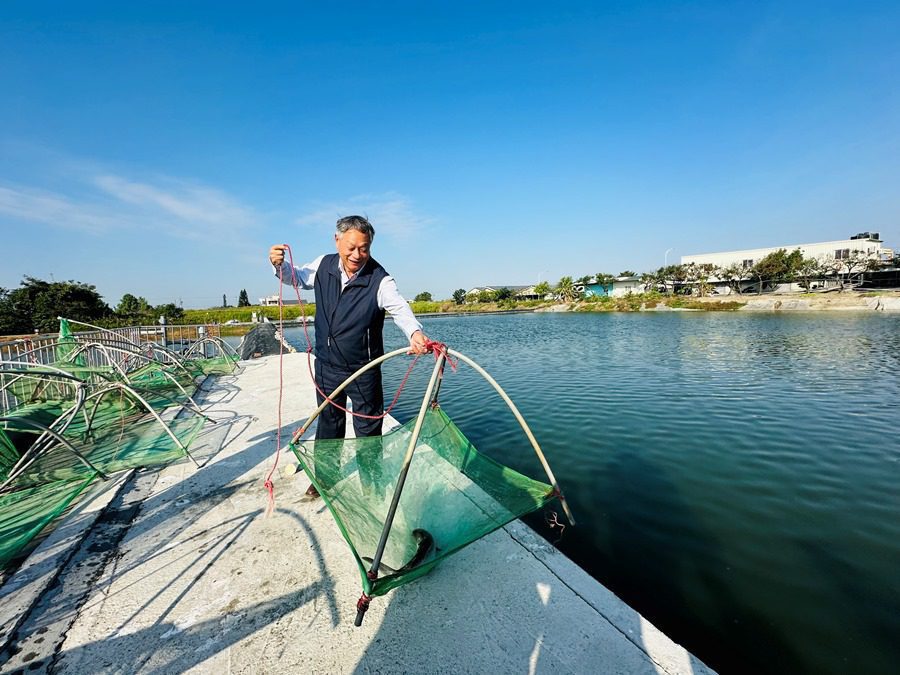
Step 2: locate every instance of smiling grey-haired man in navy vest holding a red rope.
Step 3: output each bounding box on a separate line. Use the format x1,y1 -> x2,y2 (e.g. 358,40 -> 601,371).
269,216 -> 428,497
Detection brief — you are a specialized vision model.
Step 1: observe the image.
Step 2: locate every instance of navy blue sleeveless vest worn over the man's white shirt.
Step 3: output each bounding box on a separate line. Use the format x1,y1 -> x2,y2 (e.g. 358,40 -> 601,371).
314,253 -> 387,370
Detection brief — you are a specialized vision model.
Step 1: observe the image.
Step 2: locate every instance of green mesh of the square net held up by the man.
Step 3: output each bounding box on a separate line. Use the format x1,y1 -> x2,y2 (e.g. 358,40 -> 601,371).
291,408 -> 554,596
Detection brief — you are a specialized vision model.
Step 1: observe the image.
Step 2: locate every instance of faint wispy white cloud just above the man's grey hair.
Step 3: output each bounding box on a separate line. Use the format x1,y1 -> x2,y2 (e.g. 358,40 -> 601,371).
297,192 -> 433,239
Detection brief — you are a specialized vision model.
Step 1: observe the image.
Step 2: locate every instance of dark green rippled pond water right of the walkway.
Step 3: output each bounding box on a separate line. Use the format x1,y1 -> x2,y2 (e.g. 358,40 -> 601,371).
287,313 -> 900,673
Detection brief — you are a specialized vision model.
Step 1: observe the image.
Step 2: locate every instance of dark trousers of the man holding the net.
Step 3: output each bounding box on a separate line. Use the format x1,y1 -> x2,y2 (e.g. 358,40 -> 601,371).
316,360 -> 384,441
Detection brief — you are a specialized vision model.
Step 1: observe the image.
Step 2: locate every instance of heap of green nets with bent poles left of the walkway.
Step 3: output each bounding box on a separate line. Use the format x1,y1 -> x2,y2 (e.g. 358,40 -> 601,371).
0,320 -> 236,567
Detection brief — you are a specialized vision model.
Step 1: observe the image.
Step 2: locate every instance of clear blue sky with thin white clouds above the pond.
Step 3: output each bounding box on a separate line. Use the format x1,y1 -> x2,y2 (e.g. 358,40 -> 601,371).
0,0 -> 900,307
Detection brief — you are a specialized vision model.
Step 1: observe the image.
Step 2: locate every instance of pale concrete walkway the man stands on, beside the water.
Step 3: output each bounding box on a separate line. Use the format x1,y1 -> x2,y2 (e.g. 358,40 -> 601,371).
2,354 -> 711,675
